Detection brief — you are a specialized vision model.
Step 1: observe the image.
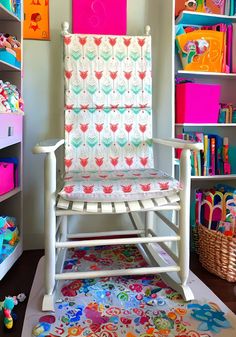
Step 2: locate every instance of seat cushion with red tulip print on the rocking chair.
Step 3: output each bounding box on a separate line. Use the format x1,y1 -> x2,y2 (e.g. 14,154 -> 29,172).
59,169 -> 180,202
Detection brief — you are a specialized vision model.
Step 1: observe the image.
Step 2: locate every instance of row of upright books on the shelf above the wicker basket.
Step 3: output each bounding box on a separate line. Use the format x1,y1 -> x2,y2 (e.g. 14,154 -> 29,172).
176,132 -> 231,176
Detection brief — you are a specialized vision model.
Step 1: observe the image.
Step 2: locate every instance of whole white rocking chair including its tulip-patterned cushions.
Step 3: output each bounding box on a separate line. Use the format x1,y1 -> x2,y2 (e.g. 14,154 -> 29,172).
34,23 -> 202,310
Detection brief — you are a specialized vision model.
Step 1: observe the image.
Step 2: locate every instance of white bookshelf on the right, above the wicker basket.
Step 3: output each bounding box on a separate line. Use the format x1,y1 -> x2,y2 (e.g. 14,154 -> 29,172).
172,8 -> 236,234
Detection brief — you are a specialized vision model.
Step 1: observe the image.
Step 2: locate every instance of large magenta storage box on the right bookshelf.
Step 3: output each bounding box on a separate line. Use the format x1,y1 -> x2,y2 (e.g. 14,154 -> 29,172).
175,83 -> 221,124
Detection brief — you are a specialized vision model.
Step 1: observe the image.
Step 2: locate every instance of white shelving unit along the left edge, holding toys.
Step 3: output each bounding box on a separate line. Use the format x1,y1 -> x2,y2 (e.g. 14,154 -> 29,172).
0,1 -> 23,280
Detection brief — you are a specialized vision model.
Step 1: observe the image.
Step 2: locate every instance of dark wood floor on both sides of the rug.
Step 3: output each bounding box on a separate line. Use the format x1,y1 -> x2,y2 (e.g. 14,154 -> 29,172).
0,250 -> 236,337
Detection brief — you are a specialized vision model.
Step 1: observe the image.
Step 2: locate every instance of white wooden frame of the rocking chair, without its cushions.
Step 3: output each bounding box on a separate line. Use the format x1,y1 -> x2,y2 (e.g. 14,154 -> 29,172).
33,24 -> 202,311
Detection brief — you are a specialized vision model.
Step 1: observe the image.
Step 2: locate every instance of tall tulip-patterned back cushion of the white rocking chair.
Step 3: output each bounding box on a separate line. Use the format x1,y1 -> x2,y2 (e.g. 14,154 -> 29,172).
64,34 -> 153,172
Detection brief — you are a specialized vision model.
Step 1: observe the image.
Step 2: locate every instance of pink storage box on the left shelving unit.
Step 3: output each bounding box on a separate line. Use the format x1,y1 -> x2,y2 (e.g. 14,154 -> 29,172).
0,162 -> 14,195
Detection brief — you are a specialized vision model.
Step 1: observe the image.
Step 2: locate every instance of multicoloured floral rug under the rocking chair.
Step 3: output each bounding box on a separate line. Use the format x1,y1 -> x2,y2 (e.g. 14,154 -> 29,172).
25,246 -> 236,337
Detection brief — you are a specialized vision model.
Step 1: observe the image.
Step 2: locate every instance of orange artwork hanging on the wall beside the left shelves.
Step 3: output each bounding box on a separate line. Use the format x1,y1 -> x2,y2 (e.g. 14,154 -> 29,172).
24,0 -> 50,40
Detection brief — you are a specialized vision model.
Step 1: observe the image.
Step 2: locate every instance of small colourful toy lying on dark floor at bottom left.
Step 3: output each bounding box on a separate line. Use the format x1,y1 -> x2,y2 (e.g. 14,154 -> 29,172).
0,293 -> 26,330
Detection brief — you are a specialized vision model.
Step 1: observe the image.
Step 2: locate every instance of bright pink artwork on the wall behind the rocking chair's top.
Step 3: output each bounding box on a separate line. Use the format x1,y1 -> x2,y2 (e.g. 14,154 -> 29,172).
72,0 -> 127,35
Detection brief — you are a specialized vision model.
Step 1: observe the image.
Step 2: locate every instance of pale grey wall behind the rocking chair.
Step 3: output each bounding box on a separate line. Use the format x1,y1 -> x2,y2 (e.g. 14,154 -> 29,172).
24,0 -> 159,249
